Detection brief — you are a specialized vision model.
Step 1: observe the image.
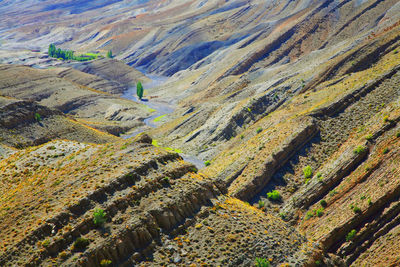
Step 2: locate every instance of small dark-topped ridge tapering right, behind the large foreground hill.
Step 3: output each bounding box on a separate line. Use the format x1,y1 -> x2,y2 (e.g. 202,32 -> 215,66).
0,97 -> 116,148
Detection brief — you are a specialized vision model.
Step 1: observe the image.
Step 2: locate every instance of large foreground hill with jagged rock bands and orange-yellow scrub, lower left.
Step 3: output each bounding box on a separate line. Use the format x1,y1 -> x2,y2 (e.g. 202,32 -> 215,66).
0,135 -> 310,266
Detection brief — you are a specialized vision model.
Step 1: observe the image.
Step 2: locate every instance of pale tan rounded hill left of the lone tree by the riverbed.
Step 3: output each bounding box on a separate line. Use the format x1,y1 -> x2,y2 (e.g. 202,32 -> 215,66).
0,63 -> 152,135
